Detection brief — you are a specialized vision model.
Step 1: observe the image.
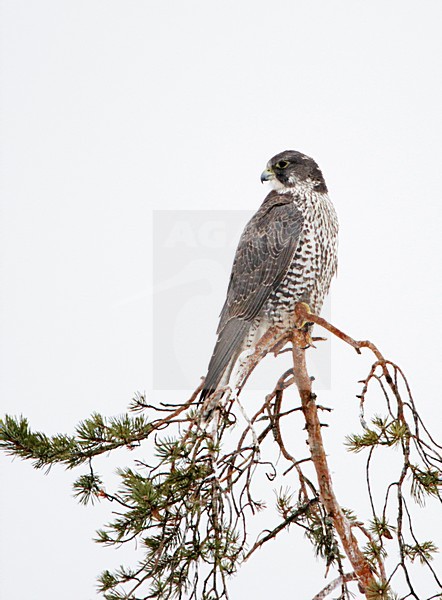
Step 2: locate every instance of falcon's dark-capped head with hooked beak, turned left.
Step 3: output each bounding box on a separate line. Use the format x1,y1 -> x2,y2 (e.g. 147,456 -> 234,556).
261,150 -> 327,193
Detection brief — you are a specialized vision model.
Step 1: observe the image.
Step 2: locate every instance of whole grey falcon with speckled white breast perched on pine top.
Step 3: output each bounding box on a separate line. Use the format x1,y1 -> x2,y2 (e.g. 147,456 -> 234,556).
201,150 -> 338,400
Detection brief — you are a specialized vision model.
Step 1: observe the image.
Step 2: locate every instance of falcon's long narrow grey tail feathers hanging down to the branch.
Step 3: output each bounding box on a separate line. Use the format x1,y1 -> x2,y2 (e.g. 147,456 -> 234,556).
200,319 -> 251,401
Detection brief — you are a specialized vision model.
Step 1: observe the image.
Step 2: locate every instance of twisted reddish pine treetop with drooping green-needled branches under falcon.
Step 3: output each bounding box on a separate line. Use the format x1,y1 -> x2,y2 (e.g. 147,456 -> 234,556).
0,304 -> 442,600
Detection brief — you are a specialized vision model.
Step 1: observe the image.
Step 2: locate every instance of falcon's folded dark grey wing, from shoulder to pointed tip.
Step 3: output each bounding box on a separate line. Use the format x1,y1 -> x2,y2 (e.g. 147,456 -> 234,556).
201,192 -> 303,398
